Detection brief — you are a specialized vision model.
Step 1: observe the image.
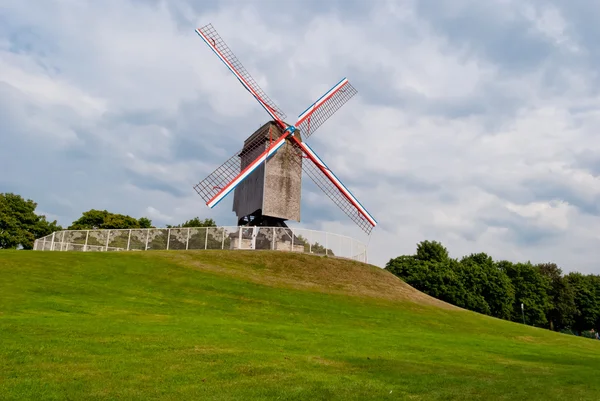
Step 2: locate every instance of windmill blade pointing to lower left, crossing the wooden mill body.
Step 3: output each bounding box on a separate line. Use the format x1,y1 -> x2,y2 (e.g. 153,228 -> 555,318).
194,131 -> 290,208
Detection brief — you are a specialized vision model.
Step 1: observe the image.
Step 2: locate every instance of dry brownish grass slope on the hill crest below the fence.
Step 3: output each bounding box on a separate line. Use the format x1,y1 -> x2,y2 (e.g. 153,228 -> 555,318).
162,251 -> 459,309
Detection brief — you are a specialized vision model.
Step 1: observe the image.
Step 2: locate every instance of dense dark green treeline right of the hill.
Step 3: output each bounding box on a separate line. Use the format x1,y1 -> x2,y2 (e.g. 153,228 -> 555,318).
385,241 -> 600,336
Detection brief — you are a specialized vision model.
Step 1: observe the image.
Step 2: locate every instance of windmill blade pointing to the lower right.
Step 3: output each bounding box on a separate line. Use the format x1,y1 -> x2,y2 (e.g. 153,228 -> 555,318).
291,136 -> 377,234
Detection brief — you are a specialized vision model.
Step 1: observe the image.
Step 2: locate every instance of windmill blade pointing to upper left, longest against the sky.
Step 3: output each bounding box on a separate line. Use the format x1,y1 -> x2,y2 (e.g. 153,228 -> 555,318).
196,24 -> 286,123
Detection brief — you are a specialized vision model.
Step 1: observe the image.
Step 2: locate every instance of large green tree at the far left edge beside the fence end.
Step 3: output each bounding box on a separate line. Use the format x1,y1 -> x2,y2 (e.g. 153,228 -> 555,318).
0,193 -> 62,249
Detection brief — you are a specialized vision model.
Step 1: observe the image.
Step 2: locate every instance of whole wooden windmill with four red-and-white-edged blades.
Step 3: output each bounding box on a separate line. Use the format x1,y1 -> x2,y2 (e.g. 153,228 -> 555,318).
194,24 -> 377,234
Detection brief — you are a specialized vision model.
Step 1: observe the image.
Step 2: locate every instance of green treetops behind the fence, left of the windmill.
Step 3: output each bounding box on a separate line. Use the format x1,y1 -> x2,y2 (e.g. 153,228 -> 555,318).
0,193 -> 216,249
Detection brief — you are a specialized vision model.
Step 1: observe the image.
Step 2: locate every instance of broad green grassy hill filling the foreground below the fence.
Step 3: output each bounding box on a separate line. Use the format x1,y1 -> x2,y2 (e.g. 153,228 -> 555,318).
0,251 -> 600,400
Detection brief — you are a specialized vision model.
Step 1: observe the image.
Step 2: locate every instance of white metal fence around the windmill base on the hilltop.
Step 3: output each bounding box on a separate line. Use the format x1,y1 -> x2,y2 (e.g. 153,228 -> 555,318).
33,226 -> 367,262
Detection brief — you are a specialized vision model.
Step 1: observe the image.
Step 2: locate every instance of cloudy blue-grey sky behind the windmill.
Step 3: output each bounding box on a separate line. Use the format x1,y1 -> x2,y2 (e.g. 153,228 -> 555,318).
0,0 -> 600,274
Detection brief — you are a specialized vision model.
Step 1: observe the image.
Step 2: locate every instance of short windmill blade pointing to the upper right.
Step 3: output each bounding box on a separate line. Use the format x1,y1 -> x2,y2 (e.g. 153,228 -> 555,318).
295,78 -> 358,140
